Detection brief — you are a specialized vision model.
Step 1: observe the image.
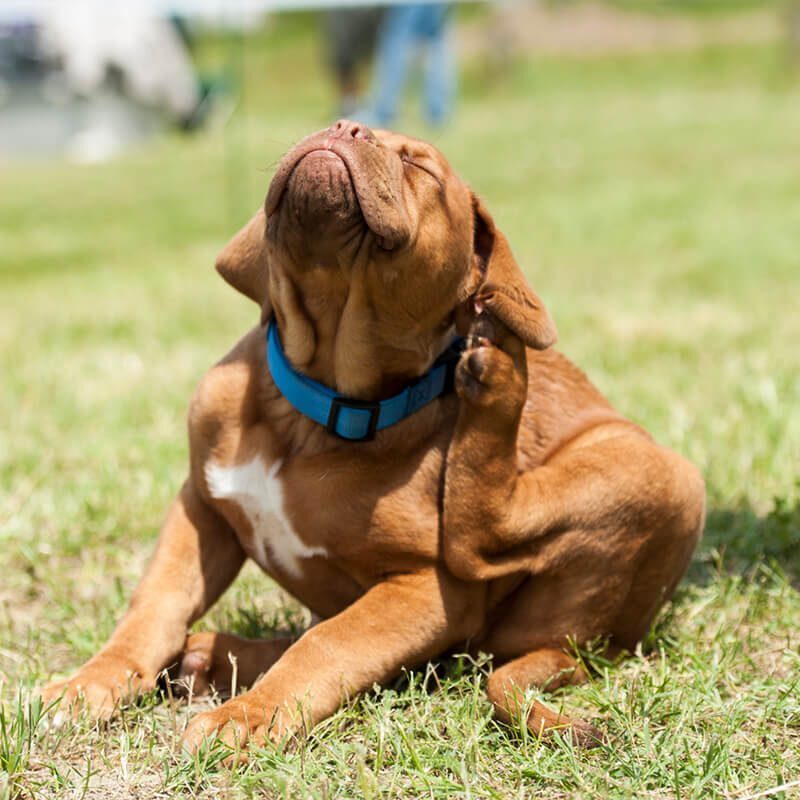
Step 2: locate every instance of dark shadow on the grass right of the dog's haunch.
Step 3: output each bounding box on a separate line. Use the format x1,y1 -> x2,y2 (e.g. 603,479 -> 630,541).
687,490 -> 800,586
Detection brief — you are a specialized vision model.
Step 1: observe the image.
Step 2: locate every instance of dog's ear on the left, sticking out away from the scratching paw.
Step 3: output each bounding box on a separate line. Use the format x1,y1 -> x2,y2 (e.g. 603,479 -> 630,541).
215,208 -> 272,324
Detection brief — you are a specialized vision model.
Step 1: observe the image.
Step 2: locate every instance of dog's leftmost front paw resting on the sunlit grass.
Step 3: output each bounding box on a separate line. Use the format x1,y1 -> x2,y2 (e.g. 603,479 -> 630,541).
38,655 -> 155,727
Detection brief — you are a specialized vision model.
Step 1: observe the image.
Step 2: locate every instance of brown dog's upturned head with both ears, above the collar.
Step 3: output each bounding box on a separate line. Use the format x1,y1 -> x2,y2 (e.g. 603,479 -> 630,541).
217,121 -> 556,397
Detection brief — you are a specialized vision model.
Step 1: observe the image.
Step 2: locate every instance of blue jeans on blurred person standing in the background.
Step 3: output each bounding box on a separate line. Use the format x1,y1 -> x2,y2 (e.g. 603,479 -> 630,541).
370,2 -> 455,125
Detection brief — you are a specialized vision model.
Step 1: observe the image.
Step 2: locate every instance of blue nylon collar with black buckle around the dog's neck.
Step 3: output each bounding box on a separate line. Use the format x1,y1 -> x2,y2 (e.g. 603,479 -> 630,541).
267,318 -> 464,442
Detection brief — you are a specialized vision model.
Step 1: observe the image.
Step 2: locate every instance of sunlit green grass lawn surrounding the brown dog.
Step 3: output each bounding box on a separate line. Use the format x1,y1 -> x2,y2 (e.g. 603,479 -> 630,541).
0,7 -> 800,800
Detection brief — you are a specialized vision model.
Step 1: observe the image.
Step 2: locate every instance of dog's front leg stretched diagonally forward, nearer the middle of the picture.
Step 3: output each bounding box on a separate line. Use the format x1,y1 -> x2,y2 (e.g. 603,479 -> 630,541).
184,569 -> 484,750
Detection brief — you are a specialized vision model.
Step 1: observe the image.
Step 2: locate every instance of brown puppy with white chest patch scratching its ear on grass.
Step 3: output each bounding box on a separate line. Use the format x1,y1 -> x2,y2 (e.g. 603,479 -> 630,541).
43,121 -> 704,748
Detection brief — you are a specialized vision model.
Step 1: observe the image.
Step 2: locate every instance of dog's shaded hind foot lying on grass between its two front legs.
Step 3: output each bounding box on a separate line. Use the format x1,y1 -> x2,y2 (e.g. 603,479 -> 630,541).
178,631 -> 294,695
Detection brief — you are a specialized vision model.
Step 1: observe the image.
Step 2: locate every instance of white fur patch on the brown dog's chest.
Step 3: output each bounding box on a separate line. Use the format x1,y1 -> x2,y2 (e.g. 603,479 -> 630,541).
205,456 -> 328,578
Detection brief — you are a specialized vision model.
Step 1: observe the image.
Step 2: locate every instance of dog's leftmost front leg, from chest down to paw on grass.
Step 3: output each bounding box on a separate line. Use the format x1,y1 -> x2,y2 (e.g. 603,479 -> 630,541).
41,481 -> 244,718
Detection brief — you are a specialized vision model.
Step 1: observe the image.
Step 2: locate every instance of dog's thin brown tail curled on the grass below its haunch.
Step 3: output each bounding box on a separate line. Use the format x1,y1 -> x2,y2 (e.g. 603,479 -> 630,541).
486,647 -> 602,746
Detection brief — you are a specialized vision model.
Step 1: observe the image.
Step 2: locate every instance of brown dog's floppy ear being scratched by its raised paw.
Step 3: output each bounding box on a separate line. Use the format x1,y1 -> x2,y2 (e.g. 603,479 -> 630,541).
472,195 -> 558,350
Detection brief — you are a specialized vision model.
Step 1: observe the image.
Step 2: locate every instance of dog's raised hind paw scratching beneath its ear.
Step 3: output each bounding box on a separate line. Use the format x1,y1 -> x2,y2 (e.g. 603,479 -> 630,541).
456,311 -> 528,417
